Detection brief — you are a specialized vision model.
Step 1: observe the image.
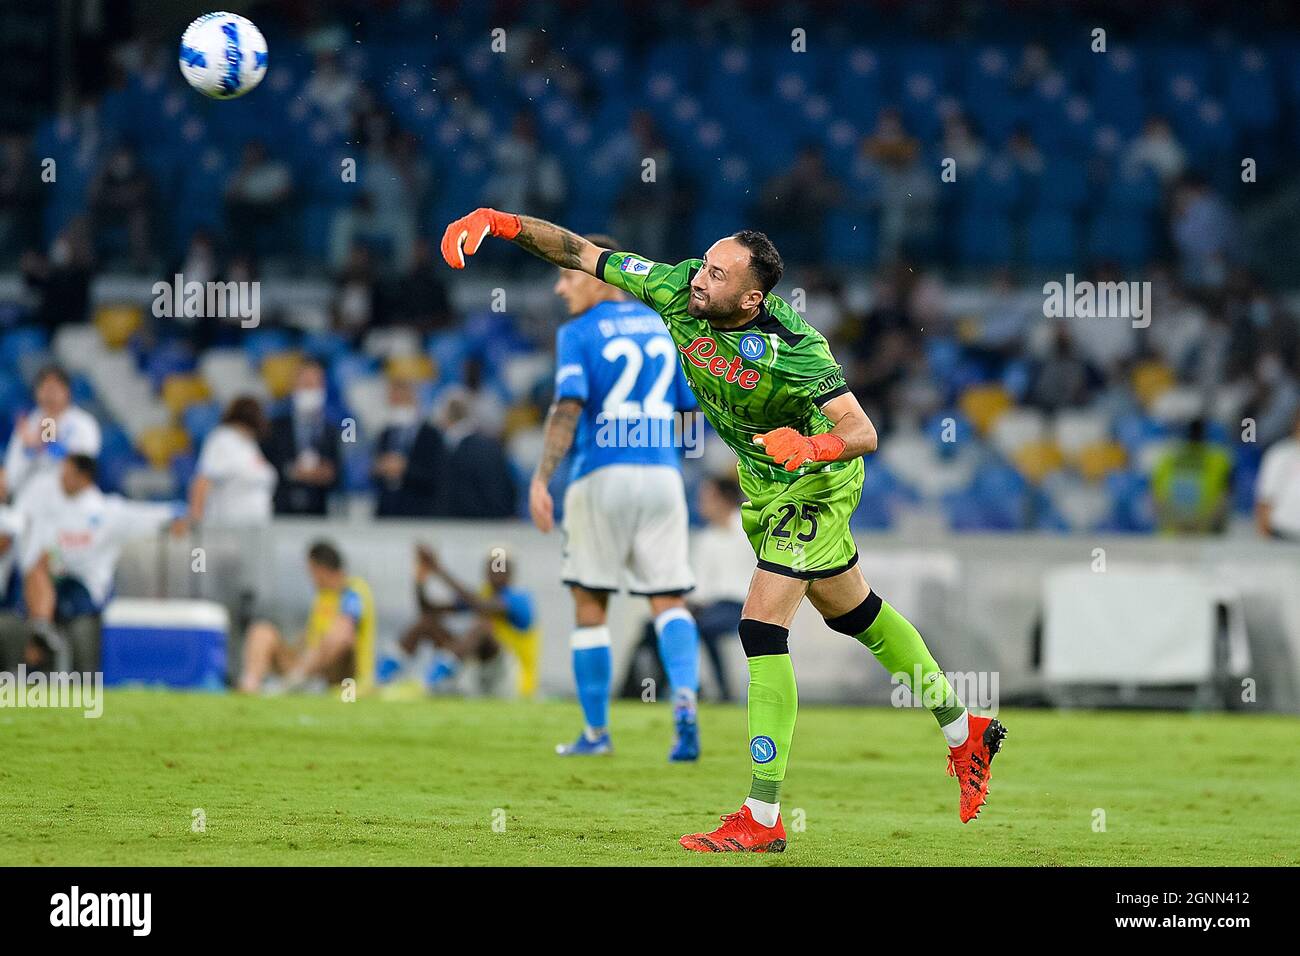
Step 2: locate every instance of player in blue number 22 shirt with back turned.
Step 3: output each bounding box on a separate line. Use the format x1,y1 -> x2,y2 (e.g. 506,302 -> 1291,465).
528,235 -> 699,761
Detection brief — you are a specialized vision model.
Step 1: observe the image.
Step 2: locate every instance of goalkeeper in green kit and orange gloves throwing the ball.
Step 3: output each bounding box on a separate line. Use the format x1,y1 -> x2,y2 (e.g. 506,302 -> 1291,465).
442,209 -> 1006,852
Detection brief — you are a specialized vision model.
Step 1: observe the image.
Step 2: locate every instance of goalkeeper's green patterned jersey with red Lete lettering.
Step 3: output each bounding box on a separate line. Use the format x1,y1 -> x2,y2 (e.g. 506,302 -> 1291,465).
595,251 -> 861,484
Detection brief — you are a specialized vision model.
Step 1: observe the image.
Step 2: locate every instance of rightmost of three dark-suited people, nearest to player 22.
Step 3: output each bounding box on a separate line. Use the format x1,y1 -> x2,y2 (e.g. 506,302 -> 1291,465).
438,389 -> 516,518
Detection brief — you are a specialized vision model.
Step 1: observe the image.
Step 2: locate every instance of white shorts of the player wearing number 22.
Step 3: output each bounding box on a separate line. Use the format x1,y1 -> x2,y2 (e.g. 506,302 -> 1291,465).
562,464 -> 696,596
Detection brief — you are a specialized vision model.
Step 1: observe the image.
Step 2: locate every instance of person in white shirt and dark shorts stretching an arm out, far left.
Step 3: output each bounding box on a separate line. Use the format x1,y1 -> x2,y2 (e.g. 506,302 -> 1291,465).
16,455 -> 189,671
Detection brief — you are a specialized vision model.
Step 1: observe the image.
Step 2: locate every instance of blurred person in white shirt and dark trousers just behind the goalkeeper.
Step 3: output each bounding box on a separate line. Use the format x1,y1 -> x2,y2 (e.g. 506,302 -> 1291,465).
690,476 -> 754,700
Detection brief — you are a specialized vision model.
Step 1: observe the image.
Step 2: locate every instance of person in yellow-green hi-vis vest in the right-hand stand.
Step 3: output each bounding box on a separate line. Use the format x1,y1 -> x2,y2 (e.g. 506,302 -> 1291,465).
1151,418 -> 1232,535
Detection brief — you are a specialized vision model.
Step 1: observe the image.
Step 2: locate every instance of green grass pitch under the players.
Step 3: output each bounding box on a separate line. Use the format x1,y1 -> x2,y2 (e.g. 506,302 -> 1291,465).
0,691 -> 1300,866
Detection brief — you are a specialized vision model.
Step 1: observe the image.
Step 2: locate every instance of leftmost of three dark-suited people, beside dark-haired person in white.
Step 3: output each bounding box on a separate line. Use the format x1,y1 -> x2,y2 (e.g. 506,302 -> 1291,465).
265,360 -> 339,515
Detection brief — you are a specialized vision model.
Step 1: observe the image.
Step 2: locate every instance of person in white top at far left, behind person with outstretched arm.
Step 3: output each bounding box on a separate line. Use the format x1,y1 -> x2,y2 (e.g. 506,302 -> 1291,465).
0,365 -> 101,501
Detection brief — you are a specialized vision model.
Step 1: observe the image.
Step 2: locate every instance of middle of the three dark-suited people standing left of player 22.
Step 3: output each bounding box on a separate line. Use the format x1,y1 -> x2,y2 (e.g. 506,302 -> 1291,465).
372,378 -> 446,518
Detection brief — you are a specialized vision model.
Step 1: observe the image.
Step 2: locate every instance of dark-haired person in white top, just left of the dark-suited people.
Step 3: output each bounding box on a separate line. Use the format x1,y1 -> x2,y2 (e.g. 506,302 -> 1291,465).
190,395 -> 280,528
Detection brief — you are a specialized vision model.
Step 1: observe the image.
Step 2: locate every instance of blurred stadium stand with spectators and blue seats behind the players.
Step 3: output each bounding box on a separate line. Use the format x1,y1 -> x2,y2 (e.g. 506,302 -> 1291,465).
0,3 -> 1300,535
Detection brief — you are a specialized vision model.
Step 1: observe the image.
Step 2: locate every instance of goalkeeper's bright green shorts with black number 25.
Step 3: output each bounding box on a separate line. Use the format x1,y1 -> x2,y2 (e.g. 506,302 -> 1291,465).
740,458 -> 863,580
